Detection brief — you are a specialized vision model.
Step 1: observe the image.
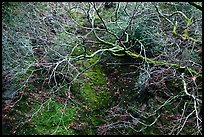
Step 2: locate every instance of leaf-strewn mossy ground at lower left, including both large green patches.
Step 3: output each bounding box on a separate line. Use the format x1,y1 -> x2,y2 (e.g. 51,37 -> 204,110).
3,52 -> 110,135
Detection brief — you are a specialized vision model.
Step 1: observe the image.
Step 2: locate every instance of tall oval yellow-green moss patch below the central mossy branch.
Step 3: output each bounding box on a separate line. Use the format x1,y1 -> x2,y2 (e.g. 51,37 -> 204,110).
75,56 -> 110,135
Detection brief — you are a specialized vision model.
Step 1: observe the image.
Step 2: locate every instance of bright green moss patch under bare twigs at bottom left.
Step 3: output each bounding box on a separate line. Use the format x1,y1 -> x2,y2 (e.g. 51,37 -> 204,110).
20,100 -> 78,135
